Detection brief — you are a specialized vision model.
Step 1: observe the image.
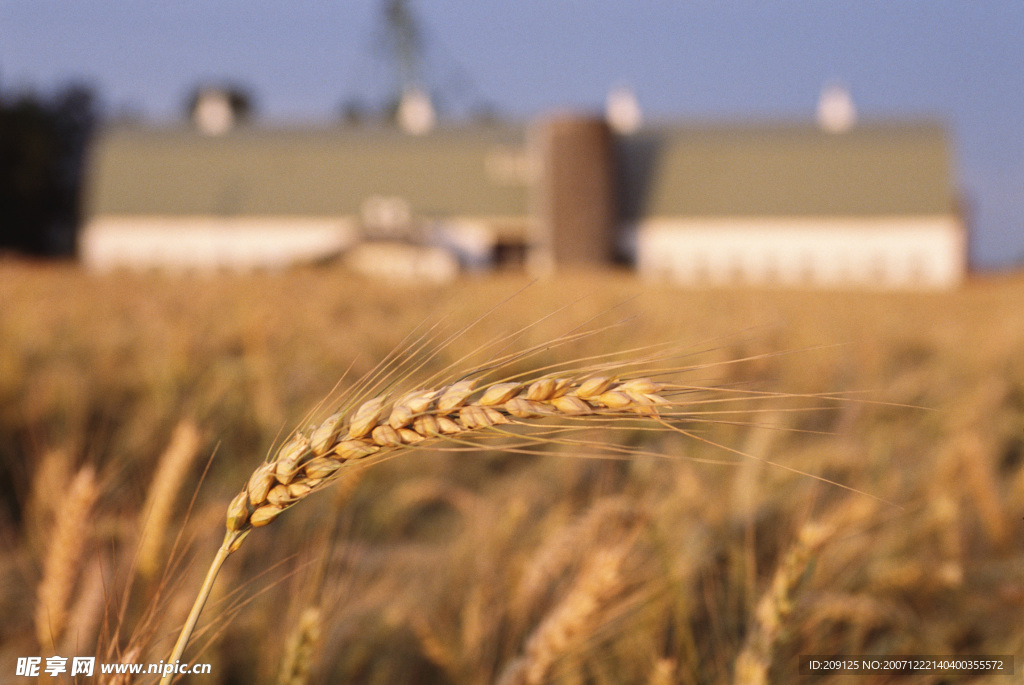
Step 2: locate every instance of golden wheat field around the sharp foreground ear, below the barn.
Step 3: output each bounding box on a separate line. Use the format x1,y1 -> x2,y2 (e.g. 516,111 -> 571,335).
0,262 -> 1024,685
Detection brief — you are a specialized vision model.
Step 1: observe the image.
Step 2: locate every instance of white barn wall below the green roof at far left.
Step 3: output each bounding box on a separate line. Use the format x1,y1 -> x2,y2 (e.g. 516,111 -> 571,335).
80,216 -> 356,270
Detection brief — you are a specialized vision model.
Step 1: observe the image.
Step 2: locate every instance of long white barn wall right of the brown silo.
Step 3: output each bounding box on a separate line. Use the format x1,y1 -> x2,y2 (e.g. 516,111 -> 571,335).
635,216 -> 967,289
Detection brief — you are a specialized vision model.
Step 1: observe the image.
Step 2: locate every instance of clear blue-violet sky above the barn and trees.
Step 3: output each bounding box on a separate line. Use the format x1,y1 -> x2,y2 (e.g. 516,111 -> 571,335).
0,0 -> 1024,267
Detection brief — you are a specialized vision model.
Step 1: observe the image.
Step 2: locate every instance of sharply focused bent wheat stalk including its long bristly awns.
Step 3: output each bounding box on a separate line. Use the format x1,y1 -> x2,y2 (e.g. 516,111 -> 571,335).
161,317 -> 859,685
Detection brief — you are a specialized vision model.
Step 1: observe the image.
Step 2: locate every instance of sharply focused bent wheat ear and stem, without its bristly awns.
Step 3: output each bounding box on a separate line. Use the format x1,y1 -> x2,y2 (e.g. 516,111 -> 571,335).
161,368 -> 672,683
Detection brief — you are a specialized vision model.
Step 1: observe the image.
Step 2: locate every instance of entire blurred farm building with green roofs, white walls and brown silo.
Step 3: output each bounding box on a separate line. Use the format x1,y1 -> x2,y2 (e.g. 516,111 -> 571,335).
80,116 -> 967,288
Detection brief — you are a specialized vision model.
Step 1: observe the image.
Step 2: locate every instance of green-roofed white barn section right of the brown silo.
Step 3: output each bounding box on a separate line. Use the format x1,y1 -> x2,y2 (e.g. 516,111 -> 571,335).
621,123 -> 967,289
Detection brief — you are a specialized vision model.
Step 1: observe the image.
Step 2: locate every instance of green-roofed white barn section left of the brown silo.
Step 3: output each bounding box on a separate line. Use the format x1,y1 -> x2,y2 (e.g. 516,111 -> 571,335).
80,126 -> 528,270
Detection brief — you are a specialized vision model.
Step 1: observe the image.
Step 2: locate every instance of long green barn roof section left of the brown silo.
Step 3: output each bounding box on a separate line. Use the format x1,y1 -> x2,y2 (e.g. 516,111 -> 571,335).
87,122 -> 526,216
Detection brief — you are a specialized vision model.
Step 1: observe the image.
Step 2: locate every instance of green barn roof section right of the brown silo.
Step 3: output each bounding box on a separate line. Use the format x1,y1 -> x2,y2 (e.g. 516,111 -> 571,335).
620,123 -> 955,218
